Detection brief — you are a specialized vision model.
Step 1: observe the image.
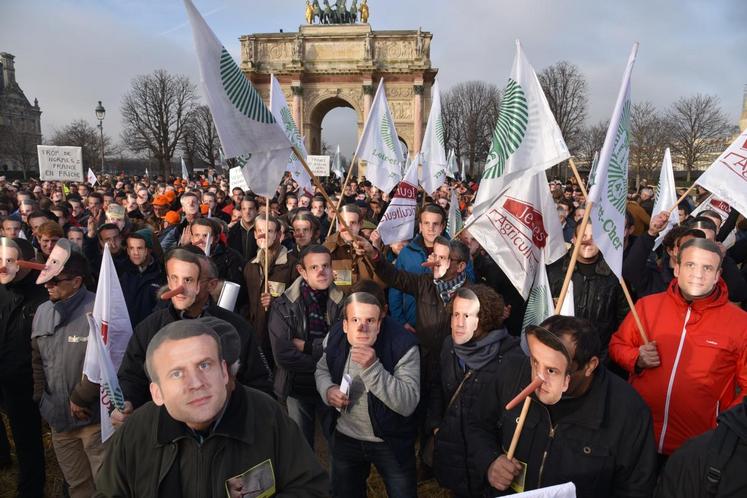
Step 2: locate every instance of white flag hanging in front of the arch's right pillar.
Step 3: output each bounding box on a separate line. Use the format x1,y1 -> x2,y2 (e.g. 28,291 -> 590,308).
351,78 -> 406,192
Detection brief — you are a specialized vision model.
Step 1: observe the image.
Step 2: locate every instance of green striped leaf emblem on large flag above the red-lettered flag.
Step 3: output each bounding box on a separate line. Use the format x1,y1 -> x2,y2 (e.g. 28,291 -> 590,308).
482,78 -> 529,179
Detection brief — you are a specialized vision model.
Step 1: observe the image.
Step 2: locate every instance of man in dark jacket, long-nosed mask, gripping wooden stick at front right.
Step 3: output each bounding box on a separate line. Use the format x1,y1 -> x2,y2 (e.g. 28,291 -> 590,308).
467,316 -> 656,498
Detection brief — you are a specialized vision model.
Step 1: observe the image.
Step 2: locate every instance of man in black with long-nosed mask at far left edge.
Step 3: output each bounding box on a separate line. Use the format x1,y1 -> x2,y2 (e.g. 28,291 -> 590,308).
0,237 -> 48,498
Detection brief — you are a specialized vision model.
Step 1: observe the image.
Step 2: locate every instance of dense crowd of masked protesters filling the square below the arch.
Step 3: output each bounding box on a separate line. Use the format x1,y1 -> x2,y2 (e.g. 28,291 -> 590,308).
0,170 -> 747,498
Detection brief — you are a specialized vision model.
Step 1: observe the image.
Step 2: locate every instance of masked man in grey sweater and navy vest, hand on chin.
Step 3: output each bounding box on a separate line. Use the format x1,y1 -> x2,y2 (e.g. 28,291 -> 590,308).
315,292 -> 420,498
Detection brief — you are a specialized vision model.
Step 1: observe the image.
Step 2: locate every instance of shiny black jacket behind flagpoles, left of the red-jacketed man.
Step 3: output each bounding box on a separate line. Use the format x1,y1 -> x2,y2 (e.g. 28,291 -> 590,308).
547,253 -> 630,357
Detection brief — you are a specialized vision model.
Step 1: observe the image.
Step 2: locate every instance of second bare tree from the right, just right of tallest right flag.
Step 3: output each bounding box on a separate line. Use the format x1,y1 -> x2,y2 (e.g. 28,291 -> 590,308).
630,102 -> 669,190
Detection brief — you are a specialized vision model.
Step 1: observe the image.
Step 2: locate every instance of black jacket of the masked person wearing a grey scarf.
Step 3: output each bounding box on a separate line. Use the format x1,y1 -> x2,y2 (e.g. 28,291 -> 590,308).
426,329 -> 524,497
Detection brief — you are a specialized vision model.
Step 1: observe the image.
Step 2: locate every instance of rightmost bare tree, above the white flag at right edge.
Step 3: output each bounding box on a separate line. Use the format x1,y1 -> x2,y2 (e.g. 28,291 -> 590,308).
666,94 -> 731,184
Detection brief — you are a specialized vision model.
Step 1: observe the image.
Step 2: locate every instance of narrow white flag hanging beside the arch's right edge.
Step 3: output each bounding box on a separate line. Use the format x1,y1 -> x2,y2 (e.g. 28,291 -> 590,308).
421,81 -> 449,195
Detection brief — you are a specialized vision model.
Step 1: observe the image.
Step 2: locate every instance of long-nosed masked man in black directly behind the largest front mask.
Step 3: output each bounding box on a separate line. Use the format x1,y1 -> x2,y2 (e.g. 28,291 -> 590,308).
112,248 -> 269,425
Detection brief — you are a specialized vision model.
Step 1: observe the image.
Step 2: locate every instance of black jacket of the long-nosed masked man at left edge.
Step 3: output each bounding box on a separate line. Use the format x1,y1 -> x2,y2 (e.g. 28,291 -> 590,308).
0,271 -> 49,379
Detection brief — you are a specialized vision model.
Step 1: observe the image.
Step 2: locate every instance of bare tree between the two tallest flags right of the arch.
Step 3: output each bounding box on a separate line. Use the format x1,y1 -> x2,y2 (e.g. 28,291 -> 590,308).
537,61 -> 588,160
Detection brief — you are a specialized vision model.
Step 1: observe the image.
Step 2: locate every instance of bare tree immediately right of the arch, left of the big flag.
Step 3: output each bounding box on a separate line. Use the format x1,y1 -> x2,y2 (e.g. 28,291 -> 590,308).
441,81 -> 500,174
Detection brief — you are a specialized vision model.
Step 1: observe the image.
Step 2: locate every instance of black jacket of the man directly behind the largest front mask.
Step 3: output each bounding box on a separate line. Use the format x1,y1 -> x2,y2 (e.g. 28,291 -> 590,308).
117,302 -> 272,408
